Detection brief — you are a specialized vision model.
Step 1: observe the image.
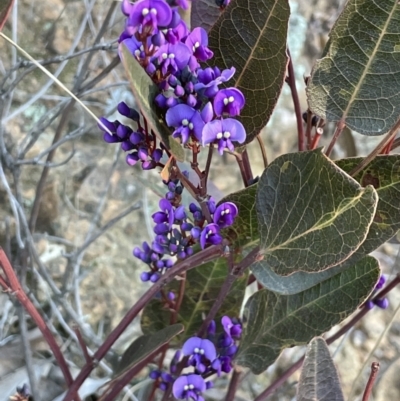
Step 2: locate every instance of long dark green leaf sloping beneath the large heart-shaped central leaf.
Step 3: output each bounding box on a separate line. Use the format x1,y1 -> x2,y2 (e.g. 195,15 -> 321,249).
236,260 -> 380,374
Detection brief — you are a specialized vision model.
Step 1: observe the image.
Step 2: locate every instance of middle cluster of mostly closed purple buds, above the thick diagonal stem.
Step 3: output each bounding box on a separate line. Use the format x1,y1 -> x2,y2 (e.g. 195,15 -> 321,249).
133,180 -> 238,283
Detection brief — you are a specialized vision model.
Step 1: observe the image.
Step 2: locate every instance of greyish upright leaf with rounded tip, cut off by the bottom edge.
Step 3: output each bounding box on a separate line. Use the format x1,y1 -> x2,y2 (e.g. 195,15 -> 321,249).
297,337 -> 344,401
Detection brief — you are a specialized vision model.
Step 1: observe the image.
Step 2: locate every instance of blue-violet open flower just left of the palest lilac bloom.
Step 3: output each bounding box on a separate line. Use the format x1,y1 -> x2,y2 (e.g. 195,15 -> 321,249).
165,104 -> 204,144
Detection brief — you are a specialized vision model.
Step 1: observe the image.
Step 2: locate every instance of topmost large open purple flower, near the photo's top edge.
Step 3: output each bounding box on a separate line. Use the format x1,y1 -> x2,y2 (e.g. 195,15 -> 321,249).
127,0 -> 172,35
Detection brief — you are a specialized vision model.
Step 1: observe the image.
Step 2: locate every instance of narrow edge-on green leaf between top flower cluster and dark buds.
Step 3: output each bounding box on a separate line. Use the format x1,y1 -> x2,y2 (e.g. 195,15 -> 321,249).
119,43 -> 185,161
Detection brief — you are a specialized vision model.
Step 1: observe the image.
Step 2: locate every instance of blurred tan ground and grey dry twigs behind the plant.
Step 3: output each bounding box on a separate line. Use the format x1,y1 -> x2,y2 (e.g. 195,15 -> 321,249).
0,0 -> 400,401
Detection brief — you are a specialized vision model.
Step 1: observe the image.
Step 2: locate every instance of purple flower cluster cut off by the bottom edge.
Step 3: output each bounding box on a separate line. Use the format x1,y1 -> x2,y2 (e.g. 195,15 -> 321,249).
150,316 -> 242,401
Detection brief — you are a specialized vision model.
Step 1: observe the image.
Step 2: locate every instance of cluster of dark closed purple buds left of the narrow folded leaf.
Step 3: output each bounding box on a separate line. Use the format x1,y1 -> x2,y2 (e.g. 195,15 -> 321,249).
99,102 -> 163,170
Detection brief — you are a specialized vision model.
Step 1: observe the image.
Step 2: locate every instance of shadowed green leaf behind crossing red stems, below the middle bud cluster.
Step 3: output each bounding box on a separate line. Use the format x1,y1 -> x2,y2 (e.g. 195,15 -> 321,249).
141,258 -> 247,340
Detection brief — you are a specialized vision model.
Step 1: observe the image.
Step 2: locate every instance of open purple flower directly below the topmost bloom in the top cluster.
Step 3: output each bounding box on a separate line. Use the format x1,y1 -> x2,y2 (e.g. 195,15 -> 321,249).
154,42 -> 191,75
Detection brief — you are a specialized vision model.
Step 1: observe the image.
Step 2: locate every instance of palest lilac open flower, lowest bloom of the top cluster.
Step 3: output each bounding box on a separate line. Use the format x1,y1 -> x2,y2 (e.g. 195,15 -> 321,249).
202,118 -> 246,155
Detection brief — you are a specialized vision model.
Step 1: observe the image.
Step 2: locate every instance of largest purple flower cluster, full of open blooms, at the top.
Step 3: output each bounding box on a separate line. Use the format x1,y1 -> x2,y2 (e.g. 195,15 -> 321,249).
119,0 -> 246,154
